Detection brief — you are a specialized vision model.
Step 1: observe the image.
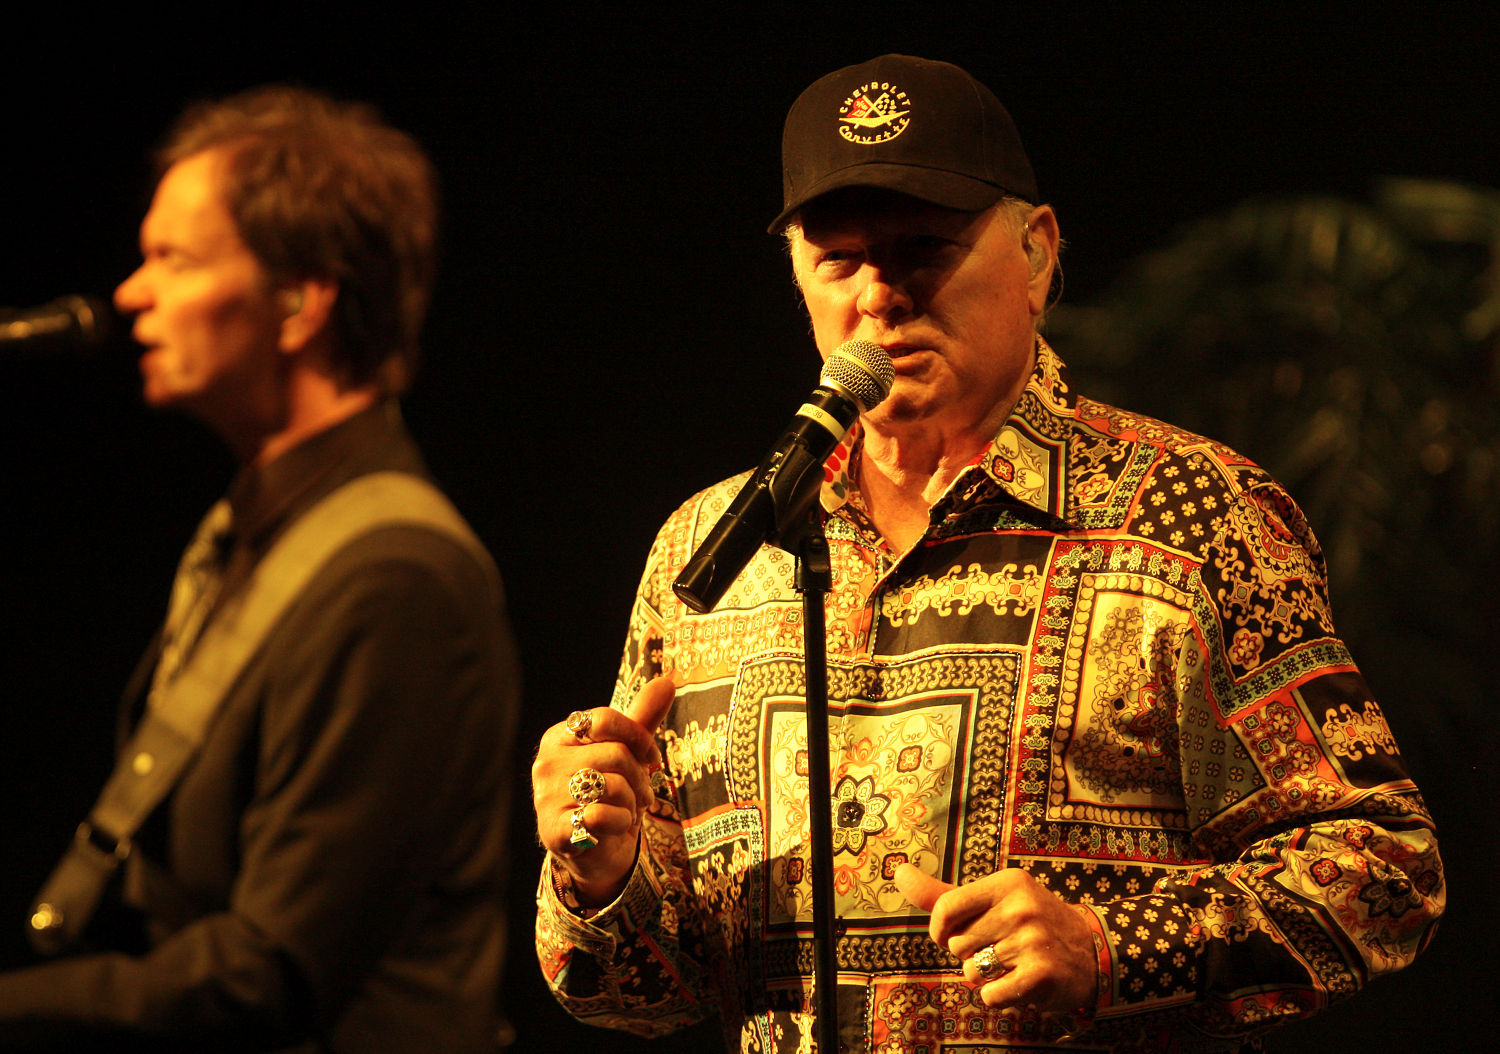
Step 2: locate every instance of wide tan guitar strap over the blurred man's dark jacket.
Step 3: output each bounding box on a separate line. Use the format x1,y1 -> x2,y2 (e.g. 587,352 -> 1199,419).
27,472 -> 501,955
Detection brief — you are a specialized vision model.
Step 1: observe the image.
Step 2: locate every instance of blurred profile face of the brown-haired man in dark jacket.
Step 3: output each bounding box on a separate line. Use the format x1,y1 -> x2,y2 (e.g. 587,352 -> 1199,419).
114,150 -> 285,444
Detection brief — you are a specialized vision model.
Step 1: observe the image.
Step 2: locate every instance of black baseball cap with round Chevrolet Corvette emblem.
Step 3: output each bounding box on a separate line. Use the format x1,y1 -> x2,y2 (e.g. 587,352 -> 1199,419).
768,55 -> 1038,234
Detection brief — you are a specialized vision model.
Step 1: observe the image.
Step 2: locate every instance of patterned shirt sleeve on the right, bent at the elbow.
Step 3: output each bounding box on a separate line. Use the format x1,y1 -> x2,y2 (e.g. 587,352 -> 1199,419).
1068,481 -> 1446,1038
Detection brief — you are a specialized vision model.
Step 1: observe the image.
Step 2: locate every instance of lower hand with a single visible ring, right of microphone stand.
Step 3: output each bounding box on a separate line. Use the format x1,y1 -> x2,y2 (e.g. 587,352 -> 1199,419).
894,864 -> 1098,1014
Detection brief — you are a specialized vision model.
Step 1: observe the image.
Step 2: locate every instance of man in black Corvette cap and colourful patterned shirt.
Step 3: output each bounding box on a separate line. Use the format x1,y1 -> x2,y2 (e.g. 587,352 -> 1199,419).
534,55 -> 1446,1053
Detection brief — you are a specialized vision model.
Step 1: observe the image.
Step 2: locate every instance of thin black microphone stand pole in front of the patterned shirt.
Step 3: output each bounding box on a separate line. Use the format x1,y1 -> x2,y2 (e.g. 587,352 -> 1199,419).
776,506 -> 839,1054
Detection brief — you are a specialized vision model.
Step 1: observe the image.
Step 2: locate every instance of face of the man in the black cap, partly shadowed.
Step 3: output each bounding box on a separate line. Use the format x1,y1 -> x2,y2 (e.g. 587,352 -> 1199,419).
791,189 -> 1055,429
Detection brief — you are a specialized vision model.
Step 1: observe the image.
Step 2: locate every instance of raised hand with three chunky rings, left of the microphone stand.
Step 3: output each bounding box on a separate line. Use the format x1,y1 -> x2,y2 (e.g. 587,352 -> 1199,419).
531,678 -> 675,907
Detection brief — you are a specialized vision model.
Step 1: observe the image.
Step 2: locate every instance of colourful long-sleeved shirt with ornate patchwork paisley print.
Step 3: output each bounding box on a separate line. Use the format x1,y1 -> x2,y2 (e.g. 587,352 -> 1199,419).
537,342 -> 1446,1054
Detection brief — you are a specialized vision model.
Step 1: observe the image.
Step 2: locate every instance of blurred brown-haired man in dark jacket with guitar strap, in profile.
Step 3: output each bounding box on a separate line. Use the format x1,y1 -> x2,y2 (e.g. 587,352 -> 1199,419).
0,87 -> 519,1051
